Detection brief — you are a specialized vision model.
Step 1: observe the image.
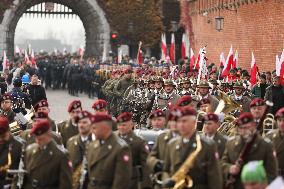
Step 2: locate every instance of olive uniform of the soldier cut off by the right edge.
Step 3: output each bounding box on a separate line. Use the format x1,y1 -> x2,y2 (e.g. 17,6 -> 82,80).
267,129 -> 284,177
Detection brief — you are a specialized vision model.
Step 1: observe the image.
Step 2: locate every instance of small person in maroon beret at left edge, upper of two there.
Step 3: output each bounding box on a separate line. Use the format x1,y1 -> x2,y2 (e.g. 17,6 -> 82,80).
1,93 -> 16,123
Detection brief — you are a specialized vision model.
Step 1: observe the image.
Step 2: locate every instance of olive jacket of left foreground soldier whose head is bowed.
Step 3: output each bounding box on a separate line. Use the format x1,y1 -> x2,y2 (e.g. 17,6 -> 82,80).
23,141 -> 72,189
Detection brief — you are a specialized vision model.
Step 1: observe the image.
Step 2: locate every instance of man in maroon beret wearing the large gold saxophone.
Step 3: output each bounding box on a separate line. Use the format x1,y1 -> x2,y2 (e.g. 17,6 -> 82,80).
163,107 -> 223,189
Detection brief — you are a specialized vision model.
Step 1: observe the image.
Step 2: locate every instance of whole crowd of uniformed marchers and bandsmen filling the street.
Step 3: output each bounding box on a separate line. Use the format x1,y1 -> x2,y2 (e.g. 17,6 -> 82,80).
0,52 -> 284,189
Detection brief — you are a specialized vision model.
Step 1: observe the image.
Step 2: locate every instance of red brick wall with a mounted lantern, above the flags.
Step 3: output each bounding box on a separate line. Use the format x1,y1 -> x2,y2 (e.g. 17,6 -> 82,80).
181,0 -> 284,71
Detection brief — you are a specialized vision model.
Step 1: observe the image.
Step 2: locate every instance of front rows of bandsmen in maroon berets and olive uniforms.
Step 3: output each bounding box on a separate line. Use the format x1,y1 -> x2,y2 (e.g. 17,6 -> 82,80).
0,89 -> 284,189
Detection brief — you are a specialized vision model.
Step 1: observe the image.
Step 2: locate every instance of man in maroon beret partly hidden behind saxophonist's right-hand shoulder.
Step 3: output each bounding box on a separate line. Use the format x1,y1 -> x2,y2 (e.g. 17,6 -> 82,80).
203,113 -> 227,157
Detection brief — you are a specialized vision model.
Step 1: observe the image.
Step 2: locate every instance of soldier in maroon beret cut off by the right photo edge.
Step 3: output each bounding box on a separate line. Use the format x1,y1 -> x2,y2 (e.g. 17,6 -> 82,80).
267,108 -> 284,177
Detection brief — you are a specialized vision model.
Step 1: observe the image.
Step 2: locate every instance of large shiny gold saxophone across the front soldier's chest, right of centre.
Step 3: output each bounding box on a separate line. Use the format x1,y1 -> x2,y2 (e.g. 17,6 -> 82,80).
162,134 -> 202,189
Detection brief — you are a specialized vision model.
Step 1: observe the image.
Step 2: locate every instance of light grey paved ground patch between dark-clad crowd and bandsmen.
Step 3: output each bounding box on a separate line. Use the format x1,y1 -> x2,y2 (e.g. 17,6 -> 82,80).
46,90 -> 94,123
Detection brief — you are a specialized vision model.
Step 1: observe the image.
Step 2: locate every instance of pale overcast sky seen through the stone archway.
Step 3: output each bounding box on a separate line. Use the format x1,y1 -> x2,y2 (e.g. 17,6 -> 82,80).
15,16 -> 85,51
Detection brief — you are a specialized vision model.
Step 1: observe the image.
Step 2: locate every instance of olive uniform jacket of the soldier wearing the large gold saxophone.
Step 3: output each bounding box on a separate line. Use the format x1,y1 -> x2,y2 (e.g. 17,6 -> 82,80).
164,133 -> 223,189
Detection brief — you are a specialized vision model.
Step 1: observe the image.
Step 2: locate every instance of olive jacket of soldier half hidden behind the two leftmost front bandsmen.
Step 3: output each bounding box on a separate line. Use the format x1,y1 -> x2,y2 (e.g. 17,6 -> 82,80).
58,119 -> 79,146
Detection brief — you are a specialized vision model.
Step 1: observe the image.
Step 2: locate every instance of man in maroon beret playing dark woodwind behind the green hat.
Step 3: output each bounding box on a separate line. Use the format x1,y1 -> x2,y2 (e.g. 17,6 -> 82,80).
222,112 -> 278,189
